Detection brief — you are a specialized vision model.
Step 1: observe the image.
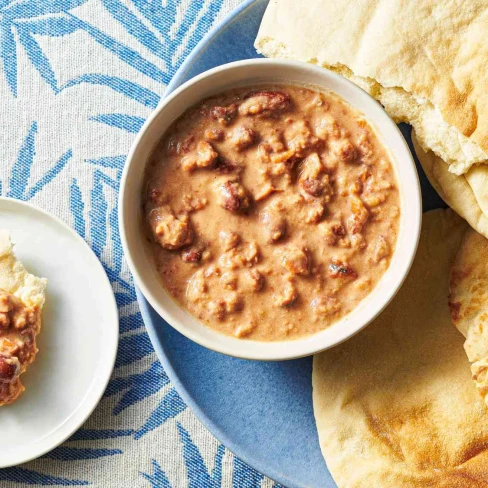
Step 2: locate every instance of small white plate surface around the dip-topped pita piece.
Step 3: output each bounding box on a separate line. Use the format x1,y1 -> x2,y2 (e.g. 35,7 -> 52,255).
0,198 -> 118,468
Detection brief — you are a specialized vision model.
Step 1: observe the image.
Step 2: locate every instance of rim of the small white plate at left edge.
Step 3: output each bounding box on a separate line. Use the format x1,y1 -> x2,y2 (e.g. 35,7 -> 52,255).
0,196 -> 119,469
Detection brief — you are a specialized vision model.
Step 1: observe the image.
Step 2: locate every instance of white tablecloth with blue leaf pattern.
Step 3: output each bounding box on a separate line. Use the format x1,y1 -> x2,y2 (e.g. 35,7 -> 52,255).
0,0 -> 273,488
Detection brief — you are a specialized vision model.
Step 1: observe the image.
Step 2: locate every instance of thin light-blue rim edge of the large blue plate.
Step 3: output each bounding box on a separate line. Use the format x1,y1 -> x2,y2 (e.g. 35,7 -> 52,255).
135,0 -> 318,487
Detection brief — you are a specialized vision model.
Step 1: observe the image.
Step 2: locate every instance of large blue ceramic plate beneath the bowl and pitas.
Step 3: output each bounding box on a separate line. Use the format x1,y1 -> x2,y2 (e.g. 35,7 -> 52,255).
138,0 -> 443,488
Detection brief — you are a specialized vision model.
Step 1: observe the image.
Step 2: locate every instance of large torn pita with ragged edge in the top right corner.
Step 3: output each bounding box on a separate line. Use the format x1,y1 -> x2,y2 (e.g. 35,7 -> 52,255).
255,0 -> 488,174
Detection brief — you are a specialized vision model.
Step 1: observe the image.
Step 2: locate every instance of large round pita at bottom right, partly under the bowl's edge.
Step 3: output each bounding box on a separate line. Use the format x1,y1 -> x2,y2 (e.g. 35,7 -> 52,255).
312,210 -> 488,488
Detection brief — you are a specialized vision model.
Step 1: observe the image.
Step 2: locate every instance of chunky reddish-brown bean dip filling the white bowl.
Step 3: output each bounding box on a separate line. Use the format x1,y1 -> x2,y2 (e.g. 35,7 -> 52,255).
143,85 -> 400,341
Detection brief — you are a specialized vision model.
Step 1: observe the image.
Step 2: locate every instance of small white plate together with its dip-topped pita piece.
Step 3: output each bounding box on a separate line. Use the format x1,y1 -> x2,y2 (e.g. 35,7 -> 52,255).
0,197 -> 119,468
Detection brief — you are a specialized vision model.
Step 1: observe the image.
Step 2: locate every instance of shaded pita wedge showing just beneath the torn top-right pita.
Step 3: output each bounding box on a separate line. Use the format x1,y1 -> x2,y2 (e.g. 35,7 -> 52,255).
412,131 -> 488,238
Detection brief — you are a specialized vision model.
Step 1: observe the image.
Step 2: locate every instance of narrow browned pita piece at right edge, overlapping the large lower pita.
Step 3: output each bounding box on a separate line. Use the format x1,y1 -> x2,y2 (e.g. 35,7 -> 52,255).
449,230 -> 488,405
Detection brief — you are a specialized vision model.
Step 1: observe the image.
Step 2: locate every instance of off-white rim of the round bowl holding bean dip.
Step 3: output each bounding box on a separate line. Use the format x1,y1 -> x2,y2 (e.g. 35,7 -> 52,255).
118,58 -> 422,361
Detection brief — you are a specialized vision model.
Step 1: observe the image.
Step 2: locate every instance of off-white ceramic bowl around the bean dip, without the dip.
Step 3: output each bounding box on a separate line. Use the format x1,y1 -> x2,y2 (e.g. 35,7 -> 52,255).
119,59 -> 422,360
